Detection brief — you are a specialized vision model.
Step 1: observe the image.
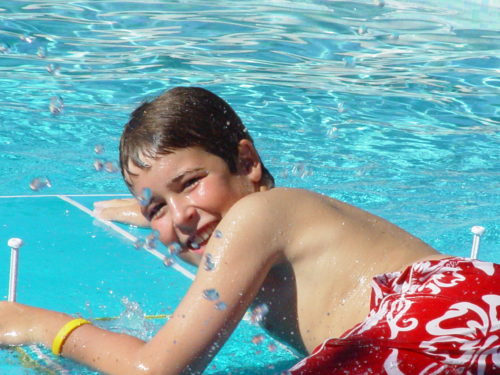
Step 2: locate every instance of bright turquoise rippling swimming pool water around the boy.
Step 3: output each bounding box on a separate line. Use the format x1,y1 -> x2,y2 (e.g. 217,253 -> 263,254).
0,0 -> 500,374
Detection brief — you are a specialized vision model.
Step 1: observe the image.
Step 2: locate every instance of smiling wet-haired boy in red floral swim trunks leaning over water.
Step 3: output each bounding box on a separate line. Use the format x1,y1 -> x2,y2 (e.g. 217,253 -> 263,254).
0,87 -> 500,375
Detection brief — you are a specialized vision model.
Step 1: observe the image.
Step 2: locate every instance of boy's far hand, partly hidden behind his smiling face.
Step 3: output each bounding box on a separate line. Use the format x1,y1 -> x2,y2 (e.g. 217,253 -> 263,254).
94,198 -> 149,227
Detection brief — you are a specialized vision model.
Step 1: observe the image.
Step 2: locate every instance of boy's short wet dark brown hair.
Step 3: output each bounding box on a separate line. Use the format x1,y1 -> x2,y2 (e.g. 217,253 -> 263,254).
120,87 -> 274,191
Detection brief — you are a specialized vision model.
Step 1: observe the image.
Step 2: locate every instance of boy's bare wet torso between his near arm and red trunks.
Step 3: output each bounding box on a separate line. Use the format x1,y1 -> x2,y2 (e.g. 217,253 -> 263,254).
250,188 -> 443,352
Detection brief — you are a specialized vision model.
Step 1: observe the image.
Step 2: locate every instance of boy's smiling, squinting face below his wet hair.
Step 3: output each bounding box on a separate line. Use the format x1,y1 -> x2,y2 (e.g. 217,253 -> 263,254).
128,147 -> 258,253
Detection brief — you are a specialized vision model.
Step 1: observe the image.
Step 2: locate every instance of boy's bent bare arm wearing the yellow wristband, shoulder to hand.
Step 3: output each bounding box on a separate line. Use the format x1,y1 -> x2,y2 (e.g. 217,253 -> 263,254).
0,192 -> 281,375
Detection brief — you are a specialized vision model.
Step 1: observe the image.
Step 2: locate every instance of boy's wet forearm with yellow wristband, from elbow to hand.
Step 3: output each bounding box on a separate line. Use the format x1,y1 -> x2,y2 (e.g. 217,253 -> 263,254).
0,302 -> 190,375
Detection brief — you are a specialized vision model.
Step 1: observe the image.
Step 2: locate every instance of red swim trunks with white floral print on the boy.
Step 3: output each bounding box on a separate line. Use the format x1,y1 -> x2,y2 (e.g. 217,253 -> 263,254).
289,257 -> 500,375
